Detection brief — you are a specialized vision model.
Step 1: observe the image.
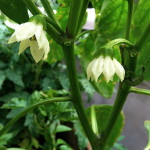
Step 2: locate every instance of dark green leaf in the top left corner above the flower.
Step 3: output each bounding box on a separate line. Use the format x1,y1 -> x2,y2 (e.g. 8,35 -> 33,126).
0,0 -> 29,24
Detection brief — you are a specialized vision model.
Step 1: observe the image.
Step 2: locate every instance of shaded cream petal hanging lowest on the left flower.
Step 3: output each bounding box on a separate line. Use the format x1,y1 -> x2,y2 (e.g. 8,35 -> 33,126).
30,41 -> 44,63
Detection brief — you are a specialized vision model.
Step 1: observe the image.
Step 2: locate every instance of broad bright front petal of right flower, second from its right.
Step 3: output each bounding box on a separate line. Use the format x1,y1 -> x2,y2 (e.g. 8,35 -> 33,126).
103,56 -> 115,82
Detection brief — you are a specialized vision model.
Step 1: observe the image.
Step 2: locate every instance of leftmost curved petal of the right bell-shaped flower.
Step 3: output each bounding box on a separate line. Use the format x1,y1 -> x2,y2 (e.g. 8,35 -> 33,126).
86,59 -> 96,81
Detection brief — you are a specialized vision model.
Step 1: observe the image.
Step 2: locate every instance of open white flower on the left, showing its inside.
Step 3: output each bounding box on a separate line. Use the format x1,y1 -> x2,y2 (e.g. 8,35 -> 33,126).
8,22 -> 50,63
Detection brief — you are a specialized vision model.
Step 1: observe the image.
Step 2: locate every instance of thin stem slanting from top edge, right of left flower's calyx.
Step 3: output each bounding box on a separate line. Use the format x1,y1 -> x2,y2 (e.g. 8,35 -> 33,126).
41,0 -> 60,26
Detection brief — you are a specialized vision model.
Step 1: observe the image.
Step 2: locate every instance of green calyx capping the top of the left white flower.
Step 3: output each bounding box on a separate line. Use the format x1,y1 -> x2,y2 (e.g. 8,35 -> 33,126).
29,14 -> 46,30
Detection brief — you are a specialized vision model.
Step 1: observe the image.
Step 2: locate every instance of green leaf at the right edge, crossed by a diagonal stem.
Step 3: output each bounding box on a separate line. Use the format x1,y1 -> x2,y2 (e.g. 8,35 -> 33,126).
131,0 -> 150,81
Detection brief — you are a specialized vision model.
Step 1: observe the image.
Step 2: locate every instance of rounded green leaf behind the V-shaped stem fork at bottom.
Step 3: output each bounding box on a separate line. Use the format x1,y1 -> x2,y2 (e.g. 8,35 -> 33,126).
87,105 -> 124,149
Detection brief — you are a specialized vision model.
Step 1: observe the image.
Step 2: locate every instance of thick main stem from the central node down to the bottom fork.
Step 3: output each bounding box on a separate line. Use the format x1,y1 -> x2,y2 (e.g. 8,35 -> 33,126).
62,44 -> 99,150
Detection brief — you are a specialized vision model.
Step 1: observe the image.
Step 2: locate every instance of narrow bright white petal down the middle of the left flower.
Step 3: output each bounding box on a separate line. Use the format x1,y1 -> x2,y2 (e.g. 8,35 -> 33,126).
35,24 -> 44,49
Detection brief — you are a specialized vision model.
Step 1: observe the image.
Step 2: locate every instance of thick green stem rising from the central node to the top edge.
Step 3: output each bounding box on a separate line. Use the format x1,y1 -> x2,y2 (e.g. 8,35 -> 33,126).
67,0 -> 82,38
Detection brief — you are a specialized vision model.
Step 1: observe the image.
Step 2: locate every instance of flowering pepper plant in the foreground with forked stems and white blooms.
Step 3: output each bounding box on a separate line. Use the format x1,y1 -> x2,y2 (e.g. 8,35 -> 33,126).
0,0 -> 150,150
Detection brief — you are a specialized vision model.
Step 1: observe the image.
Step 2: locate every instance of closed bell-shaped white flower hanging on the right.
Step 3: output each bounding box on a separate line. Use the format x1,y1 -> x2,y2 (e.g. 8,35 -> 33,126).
87,56 -> 125,82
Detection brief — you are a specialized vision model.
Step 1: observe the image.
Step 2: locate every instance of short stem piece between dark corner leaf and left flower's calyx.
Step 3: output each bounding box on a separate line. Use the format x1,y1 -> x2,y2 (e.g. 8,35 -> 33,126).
23,0 -> 42,15
